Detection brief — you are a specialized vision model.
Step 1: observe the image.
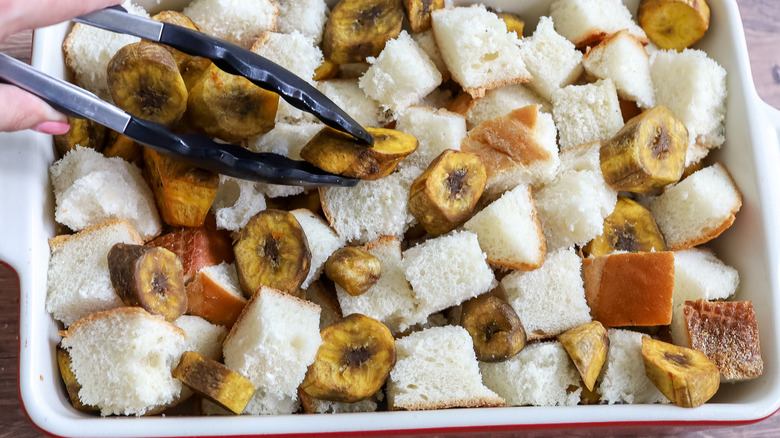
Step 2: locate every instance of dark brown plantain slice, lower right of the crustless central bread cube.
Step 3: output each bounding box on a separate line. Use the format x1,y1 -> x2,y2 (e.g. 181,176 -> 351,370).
460,294 -> 526,362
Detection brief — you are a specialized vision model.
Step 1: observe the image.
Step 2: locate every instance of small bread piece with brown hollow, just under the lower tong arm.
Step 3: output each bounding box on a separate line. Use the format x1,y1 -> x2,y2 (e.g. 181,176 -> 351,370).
211,175 -> 265,231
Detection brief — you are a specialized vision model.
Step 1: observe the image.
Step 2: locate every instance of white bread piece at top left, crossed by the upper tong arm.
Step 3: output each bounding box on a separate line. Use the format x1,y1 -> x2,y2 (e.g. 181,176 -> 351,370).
62,0 -> 149,102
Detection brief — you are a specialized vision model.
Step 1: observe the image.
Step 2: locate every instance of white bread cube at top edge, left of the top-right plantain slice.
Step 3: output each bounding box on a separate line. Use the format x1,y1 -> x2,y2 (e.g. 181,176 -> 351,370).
550,0 -> 648,47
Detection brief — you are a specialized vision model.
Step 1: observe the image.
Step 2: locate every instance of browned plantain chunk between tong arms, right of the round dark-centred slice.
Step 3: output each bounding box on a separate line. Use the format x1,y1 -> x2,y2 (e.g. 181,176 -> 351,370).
187,64 -> 279,143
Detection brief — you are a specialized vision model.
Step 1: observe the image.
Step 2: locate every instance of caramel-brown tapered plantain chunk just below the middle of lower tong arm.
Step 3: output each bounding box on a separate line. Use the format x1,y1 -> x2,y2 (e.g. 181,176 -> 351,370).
143,148 -> 219,227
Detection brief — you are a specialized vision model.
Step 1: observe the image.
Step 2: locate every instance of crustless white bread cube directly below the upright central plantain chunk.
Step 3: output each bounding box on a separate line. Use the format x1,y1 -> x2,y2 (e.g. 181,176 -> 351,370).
401,231 -> 495,315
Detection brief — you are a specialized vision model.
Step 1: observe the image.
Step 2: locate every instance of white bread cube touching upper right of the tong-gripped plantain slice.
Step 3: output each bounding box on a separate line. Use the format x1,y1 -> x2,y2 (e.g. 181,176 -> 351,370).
395,105 -> 466,169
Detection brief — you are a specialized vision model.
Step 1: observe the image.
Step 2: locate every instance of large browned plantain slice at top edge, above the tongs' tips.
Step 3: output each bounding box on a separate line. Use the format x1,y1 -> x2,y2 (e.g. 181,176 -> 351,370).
322,0 -> 404,64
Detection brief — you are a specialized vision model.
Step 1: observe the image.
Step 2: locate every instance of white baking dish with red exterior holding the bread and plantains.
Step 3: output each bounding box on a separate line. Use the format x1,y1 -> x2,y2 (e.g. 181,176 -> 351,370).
0,0 -> 780,437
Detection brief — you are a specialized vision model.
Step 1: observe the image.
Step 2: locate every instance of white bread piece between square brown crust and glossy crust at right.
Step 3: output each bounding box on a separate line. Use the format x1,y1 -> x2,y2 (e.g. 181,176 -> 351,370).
670,248 -> 739,347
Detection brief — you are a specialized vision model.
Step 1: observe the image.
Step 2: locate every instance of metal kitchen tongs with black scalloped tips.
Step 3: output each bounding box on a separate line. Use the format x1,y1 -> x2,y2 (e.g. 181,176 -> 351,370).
0,6 -> 373,186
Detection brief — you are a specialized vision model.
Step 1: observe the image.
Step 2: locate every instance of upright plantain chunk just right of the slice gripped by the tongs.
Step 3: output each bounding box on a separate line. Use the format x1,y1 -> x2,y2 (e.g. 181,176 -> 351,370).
409,149 -> 487,235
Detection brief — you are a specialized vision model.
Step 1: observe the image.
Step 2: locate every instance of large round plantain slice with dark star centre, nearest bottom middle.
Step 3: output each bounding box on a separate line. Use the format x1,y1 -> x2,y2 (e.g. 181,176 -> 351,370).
300,313 -> 396,403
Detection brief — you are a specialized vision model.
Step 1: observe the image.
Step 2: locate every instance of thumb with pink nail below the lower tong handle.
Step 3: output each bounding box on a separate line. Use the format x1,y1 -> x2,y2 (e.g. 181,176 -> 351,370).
0,84 -> 70,135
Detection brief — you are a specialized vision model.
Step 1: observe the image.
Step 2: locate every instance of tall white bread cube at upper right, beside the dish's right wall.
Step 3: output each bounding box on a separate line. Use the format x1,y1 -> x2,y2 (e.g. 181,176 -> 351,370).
650,49 -> 727,165
